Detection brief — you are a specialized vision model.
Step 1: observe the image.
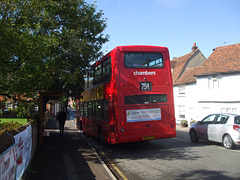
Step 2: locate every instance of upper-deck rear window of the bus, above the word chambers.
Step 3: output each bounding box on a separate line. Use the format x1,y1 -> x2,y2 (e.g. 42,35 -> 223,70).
124,53 -> 164,68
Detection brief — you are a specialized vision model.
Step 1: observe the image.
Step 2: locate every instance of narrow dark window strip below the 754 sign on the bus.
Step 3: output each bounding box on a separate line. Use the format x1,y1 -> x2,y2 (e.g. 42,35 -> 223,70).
125,94 -> 167,105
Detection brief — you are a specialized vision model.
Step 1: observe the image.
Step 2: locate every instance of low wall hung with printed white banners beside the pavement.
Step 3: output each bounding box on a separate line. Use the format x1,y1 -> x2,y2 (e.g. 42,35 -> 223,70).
0,122 -> 38,179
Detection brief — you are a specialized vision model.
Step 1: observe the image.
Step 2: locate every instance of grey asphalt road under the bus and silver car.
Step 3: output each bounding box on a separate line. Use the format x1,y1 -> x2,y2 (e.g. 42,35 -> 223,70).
88,127 -> 240,180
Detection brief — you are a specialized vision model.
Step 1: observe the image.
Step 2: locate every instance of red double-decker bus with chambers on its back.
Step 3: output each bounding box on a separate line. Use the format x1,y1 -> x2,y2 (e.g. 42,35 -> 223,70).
77,45 -> 176,144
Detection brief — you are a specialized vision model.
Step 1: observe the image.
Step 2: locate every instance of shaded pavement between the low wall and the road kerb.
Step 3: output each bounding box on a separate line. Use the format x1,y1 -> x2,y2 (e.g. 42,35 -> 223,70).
22,117 -> 115,180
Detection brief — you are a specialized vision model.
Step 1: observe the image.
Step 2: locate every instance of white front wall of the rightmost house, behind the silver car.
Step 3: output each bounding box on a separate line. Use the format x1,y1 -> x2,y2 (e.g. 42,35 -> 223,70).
197,74 -> 240,114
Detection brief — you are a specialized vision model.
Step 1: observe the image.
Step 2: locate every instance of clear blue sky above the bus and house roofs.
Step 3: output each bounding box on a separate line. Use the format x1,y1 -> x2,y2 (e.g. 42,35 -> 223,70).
87,0 -> 240,59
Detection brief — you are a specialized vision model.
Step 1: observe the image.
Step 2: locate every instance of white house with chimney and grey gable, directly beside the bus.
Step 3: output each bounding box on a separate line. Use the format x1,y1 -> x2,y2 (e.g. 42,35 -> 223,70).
171,43 -> 206,123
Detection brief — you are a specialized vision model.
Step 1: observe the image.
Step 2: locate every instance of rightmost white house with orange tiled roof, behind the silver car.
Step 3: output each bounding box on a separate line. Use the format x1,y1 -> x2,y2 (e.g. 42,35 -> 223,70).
195,43 -> 240,114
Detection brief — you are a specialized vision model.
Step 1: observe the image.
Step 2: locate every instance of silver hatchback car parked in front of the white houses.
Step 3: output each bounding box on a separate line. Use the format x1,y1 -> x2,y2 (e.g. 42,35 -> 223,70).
189,113 -> 240,149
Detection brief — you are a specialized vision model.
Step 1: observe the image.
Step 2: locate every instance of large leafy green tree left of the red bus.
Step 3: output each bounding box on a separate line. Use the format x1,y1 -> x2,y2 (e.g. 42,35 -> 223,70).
0,0 -> 108,98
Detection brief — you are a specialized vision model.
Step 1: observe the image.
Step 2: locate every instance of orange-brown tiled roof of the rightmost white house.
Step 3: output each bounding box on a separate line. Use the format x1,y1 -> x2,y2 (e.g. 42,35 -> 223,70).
195,43 -> 240,75
